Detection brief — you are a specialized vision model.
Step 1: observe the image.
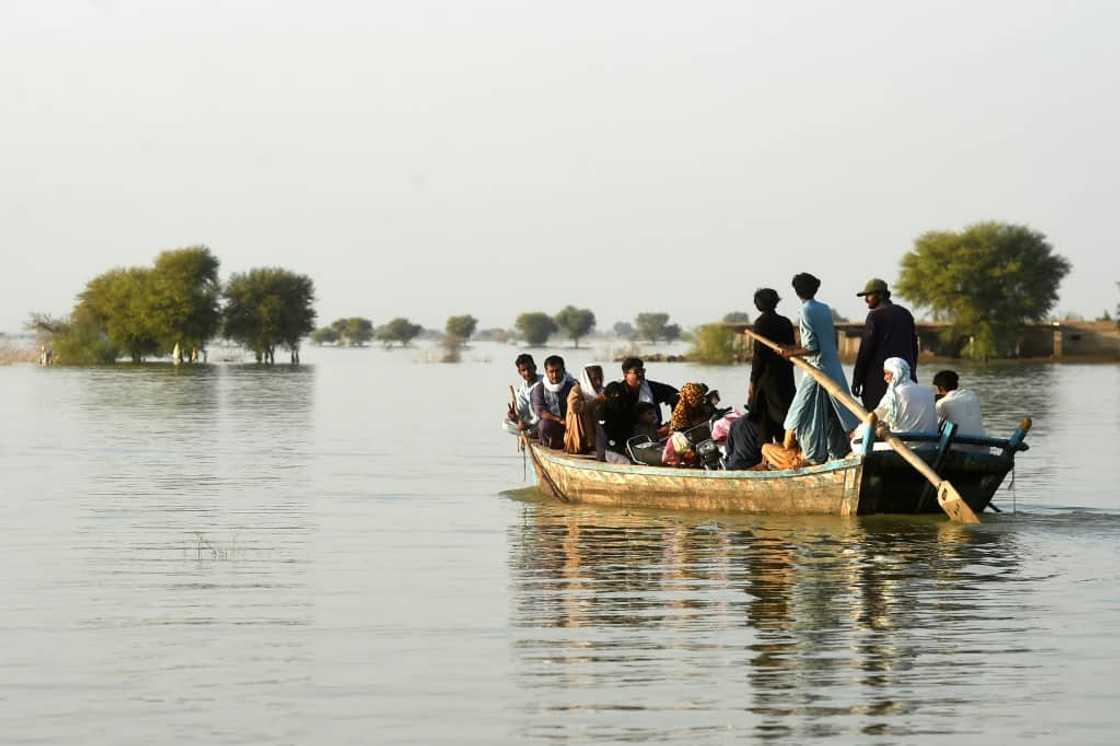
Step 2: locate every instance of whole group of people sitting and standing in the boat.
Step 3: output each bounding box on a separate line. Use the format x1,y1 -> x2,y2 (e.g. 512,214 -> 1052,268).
503,272 -> 984,469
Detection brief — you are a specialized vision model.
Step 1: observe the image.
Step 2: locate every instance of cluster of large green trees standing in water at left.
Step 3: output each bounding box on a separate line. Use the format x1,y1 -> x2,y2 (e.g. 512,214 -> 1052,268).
27,245 -> 315,365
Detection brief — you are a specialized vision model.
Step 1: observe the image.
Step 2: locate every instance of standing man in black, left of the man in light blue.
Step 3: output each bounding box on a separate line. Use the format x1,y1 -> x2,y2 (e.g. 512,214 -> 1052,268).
747,288 -> 796,442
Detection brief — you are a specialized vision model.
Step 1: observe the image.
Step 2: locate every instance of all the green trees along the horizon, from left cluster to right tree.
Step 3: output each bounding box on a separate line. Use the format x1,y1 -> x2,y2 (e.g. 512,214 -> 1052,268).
37,222 -> 1075,364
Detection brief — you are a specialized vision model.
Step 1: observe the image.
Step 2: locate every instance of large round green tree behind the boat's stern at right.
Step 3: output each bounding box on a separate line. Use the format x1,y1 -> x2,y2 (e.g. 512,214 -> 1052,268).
896,222 -> 1071,358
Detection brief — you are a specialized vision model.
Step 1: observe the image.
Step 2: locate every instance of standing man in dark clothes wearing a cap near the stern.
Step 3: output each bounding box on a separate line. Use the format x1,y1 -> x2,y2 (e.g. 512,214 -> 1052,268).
851,278 -> 917,411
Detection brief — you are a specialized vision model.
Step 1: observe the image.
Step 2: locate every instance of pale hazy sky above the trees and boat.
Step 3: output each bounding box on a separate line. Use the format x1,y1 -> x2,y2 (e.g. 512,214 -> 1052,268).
0,0 -> 1120,330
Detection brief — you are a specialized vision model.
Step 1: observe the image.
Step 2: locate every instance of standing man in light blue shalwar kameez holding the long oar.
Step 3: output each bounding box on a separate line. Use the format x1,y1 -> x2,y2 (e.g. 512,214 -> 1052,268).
785,273 -> 859,464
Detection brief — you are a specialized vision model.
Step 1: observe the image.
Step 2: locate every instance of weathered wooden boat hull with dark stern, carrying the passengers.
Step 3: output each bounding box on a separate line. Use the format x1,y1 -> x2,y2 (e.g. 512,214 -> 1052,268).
526,420 -> 1030,515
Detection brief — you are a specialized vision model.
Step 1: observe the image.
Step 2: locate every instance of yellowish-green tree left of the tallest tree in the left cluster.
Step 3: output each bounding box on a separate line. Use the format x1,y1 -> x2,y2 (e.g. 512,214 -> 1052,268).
77,267 -> 160,363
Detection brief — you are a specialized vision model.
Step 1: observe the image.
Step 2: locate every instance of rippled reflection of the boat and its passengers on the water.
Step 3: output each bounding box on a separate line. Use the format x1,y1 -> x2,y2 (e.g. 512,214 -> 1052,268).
508,503 -> 1037,740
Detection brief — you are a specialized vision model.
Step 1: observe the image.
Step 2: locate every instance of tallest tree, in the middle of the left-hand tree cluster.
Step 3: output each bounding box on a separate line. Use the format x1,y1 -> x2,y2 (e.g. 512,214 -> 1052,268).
149,246 -> 222,357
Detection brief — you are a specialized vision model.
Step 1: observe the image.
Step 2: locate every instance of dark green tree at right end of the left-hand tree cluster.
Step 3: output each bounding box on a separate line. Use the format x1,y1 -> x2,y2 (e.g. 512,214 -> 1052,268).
223,268 -> 315,365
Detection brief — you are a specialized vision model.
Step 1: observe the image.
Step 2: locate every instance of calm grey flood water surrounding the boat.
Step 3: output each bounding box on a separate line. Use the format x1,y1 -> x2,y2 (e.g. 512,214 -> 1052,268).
0,345 -> 1120,745
